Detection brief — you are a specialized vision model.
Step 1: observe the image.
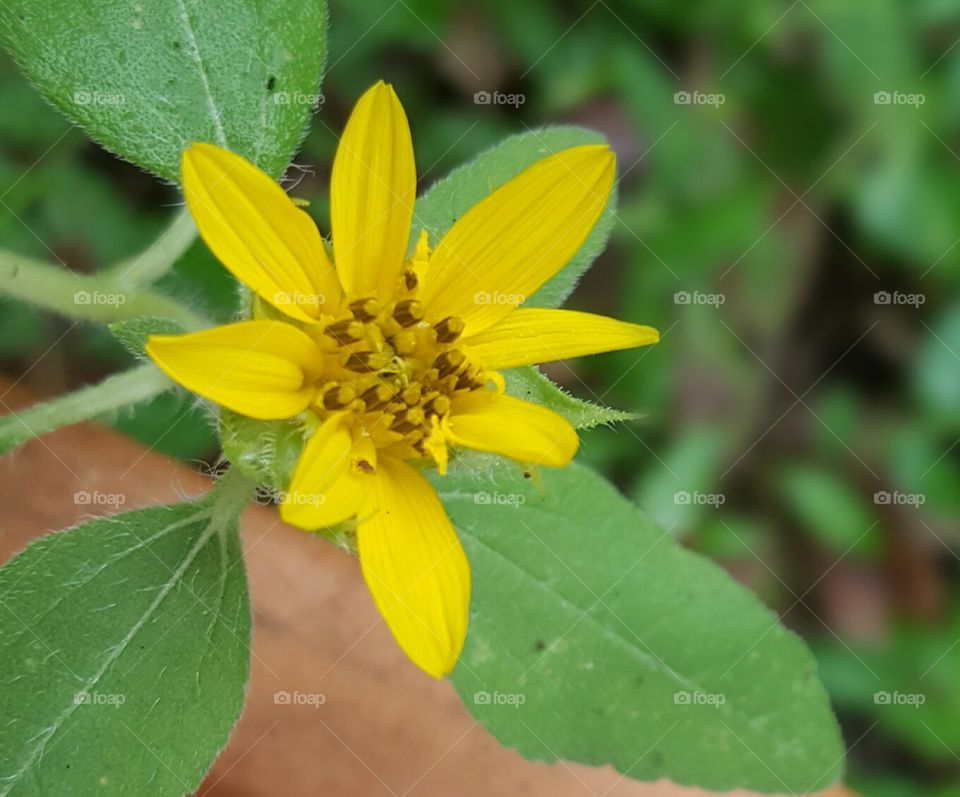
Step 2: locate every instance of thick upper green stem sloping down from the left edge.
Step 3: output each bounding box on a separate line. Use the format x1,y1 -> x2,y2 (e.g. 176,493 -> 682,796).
0,250 -> 209,329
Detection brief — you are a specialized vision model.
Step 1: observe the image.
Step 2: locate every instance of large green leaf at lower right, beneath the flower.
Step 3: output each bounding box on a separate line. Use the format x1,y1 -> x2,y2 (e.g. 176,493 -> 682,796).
437,462 -> 842,794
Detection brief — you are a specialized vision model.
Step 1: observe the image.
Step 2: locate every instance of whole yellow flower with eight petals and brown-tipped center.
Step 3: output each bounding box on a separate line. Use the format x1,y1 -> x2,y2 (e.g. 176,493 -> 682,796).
147,82 -> 658,677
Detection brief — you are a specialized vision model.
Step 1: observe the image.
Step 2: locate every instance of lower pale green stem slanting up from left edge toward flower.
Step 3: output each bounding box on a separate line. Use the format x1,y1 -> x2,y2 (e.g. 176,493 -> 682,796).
0,363 -> 171,454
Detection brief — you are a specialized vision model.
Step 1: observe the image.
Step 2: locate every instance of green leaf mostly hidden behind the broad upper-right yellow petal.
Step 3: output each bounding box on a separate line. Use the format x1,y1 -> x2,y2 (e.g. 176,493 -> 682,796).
410,127 -> 617,307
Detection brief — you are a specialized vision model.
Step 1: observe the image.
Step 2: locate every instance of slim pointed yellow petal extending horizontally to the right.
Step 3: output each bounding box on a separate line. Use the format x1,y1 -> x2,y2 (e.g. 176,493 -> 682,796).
463,308 -> 660,368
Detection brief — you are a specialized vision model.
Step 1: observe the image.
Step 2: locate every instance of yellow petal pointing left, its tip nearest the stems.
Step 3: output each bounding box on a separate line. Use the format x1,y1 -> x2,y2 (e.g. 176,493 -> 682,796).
146,321 -> 322,420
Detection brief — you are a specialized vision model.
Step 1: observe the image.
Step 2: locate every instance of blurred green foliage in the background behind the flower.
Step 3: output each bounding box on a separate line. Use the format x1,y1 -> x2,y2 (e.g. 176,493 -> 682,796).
0,0 -> 960,797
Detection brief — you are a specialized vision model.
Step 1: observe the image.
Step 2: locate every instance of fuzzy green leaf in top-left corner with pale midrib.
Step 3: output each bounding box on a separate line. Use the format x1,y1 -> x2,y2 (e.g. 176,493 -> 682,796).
0,0 -> 327,182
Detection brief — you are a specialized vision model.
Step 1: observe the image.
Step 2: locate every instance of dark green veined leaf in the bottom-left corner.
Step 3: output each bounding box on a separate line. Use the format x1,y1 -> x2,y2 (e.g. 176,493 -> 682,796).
0,480 -> 250,797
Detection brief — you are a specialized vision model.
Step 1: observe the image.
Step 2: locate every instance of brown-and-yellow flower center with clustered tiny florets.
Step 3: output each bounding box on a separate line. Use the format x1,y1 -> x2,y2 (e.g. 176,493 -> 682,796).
314,286 -> 486,463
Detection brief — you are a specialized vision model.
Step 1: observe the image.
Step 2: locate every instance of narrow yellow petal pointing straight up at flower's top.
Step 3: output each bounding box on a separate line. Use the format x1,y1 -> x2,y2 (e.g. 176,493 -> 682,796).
330,81 -> 417,300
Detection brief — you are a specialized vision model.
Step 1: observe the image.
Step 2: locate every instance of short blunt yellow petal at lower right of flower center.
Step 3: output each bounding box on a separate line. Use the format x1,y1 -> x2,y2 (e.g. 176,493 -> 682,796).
447,391 -> 580,467
